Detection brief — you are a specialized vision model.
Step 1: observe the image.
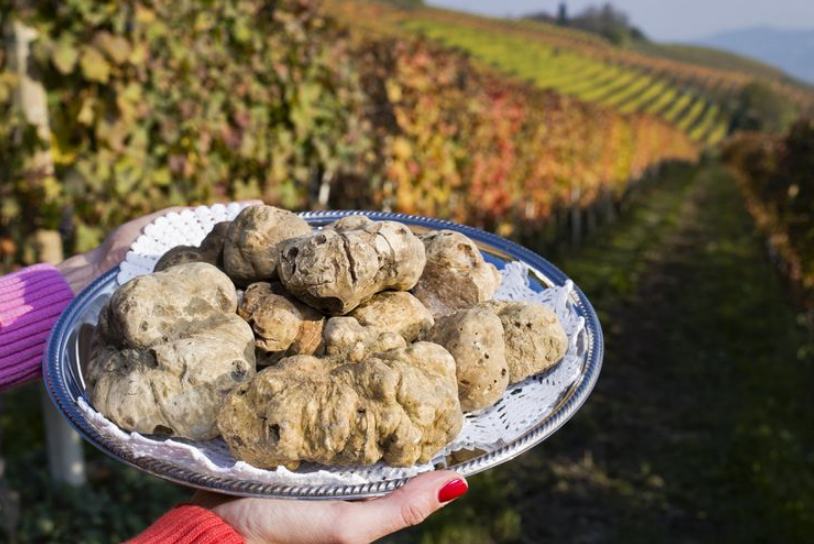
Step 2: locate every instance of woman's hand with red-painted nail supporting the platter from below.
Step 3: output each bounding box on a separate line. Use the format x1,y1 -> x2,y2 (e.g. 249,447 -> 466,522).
192,471 -> 467,544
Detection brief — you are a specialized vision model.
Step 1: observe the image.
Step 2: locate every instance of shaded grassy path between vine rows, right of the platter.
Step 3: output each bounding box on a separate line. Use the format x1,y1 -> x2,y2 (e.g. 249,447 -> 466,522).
399,165 -> 814,544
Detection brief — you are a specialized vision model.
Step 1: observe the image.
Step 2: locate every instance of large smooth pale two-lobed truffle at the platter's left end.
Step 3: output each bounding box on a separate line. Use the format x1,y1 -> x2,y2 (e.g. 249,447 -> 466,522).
85,263 -> 255,440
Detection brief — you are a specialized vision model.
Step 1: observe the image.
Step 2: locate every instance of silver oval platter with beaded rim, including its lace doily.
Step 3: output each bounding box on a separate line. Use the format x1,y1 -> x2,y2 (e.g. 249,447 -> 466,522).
43,205 -> 603,499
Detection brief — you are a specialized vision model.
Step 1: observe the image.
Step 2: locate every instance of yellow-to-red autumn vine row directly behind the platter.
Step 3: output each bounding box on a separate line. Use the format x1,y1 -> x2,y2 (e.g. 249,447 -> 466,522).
0,0 -> 698,266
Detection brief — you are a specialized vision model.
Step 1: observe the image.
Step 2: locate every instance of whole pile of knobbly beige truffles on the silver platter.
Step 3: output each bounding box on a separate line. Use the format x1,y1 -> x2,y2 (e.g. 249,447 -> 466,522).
86,206 -> 568,469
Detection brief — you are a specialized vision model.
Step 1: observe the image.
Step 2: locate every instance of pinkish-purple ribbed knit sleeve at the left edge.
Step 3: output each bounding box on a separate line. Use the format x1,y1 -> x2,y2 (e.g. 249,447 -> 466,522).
0,264 -> 73,391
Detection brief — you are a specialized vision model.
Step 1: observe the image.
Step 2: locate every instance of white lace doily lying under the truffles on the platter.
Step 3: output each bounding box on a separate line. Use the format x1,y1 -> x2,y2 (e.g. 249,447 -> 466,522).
91,204 -> 588,485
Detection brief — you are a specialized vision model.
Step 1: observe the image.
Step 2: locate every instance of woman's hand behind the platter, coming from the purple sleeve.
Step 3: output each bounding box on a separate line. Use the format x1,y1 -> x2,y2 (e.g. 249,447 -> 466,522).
57,200 -> 262,293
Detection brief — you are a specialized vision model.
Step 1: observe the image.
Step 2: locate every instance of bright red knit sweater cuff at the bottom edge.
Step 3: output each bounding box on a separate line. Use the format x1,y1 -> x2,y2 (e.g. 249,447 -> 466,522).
125,504 -> 244,544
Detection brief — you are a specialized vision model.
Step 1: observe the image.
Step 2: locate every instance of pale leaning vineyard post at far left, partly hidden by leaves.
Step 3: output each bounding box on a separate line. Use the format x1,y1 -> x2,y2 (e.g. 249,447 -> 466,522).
4,19 -> 85,486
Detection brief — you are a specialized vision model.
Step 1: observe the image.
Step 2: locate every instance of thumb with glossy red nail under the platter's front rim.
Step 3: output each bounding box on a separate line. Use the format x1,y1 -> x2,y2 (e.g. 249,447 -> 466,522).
343,470 -> 468,542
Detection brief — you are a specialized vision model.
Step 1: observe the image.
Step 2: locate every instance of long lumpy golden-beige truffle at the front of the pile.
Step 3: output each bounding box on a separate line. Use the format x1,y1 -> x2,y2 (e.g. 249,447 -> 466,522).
218,342 -> 463,469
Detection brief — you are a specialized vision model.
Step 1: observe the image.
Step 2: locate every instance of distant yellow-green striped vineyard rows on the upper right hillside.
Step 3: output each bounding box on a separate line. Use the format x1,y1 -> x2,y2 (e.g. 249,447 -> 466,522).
332,2 -> 814,145
